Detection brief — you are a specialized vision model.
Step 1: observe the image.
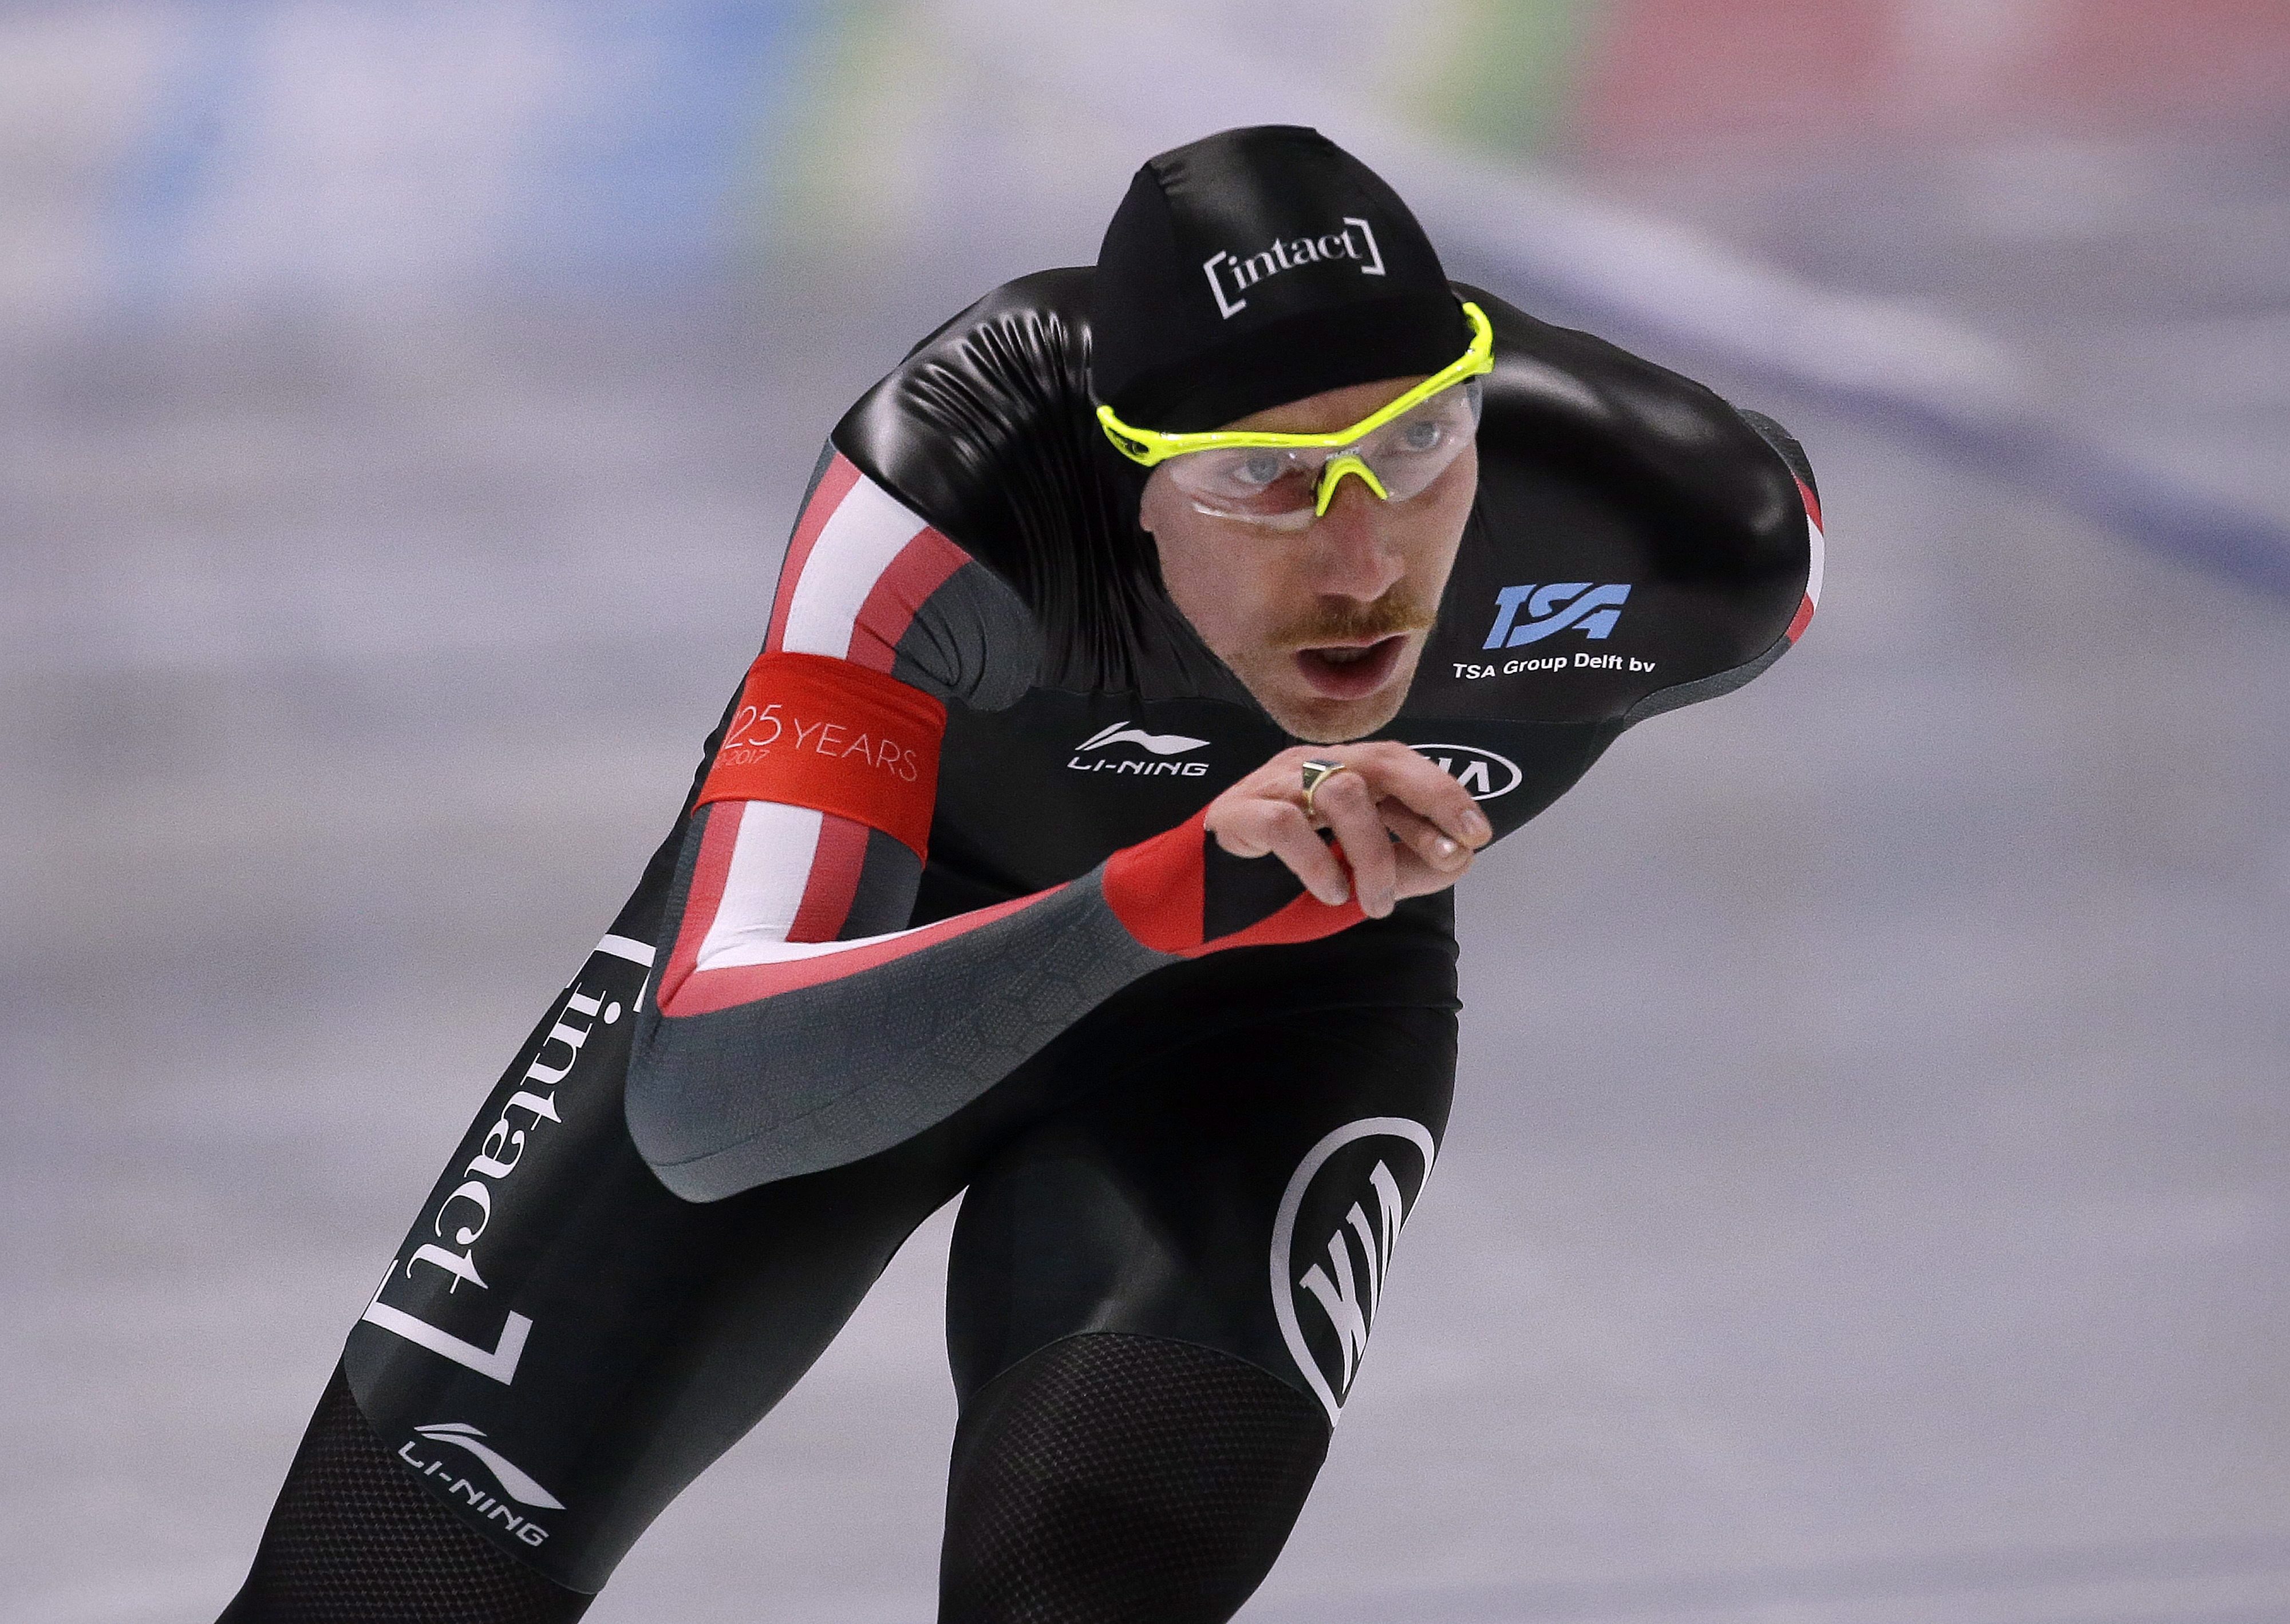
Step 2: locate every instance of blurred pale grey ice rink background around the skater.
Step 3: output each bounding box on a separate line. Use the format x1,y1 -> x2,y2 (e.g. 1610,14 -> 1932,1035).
0,0 -> 2290,1624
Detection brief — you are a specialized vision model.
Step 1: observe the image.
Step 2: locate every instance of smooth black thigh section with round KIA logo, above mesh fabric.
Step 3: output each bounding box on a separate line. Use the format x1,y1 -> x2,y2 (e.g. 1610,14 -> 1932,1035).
948,989 -> 1456,1425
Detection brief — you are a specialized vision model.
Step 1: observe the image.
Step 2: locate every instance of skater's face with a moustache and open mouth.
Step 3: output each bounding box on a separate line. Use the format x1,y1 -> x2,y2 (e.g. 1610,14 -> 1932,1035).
1138,378 -> 1479,744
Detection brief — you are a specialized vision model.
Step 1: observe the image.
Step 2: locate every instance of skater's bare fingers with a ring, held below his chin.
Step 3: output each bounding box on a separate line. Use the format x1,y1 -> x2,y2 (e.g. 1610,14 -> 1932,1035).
1207,740 -> 1495,919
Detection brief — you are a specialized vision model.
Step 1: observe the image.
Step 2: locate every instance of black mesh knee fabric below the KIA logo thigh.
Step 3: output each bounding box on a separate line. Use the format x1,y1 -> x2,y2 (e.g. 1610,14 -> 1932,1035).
939,1333 -> 1328,1624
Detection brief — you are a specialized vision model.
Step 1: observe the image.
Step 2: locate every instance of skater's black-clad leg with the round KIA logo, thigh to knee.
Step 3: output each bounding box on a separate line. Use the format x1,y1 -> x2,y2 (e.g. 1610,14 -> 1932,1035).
939,1006 -> 1454,1624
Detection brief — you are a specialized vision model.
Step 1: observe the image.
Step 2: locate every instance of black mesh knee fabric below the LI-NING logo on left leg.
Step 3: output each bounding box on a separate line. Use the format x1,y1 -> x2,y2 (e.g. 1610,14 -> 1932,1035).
218,1365 -> 595,1624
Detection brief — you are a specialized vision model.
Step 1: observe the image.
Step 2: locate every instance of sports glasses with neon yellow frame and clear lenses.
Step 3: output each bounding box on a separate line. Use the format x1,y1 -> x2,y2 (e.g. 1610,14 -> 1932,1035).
1097,300 -> 1495,529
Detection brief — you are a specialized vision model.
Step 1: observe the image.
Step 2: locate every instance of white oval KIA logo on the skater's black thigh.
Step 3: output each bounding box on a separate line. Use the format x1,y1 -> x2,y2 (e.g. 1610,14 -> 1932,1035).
1273,1116 -> 1438,1427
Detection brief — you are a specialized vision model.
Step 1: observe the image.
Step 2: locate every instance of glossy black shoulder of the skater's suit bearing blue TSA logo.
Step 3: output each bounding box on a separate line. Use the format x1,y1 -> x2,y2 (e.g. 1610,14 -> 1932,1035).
1408,289 -> 1818,728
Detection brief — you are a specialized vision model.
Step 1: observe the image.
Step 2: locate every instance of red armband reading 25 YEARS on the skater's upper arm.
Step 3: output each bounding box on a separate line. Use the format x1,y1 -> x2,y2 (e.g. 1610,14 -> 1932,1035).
698,655 -> 946,857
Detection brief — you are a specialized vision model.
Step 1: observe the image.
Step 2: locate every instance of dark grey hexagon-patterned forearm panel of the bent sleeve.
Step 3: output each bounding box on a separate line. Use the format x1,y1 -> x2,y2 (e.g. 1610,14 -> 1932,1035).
627,871 -> 1175,1200
